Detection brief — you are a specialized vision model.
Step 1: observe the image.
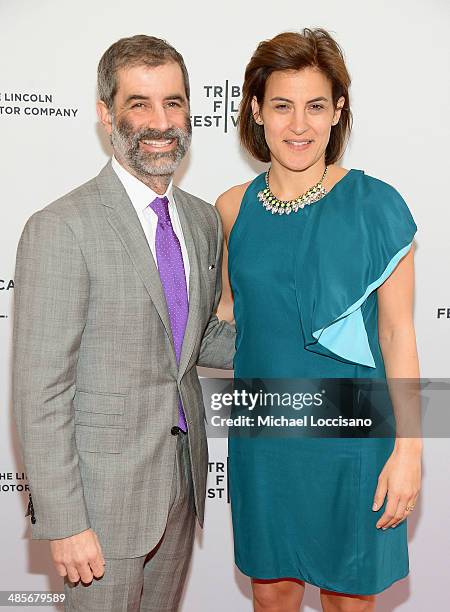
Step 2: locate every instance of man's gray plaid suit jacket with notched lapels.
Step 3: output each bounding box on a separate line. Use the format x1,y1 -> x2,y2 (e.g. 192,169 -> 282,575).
13,163 -> 235,558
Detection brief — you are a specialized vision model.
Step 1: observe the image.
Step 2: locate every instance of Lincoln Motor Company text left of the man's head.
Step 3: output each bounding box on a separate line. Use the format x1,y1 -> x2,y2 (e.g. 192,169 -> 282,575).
0,91 -> 78,119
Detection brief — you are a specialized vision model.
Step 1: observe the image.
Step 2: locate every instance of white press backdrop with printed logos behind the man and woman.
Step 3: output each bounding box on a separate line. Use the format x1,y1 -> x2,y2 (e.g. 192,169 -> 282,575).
0,0 -> 450,612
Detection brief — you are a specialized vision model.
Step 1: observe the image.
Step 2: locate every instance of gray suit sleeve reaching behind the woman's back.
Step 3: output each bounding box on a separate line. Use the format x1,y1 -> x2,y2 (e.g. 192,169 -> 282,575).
197,207 -> 236,370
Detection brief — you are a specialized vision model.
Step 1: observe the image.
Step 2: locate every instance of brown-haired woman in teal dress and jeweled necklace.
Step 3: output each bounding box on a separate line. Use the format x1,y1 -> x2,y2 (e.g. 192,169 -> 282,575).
217,29 -> 421,612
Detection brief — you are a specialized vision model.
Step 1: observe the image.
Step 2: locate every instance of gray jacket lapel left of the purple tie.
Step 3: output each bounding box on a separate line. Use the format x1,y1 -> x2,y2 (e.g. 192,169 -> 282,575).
97,162 -> 175,357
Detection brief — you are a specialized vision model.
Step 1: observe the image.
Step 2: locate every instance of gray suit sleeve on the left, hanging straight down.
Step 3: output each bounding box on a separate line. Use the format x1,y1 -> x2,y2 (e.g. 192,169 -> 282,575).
13,209 -> 90,539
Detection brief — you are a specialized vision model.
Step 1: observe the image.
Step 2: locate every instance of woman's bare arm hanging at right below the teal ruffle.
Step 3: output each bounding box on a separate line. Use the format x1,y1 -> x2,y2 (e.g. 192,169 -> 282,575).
373,245 -> 422,529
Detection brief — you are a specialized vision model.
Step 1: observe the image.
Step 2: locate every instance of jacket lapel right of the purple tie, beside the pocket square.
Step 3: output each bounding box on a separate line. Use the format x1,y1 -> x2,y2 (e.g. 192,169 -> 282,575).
173,187 -> 201,379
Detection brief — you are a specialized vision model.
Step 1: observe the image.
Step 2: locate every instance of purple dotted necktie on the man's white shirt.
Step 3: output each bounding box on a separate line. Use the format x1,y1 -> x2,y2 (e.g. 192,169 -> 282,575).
150,197 -> 189,431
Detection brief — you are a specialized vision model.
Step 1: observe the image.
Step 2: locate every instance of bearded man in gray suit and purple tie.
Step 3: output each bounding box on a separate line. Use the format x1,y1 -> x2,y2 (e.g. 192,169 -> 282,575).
13,35 -> 235,612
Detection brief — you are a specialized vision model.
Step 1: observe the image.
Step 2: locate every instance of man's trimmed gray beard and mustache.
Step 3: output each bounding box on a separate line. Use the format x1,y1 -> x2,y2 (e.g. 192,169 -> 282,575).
111,116 -> 192,177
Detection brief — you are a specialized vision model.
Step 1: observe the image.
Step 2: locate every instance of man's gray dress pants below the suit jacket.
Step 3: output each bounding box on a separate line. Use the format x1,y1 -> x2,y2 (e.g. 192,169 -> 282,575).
64,432 -> 195,612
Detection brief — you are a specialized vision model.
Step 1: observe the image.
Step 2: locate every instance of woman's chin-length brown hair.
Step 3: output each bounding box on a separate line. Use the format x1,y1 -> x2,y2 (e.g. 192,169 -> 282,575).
238,28 -> 352,164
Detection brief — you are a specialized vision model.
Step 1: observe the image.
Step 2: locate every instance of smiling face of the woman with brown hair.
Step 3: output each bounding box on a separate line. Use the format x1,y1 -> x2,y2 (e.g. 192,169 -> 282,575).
252,67 -> 345,171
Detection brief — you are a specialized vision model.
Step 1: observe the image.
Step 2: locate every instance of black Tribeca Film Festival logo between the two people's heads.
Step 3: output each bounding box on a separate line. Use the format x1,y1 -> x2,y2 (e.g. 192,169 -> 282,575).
191,79 -> 241,134
